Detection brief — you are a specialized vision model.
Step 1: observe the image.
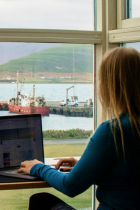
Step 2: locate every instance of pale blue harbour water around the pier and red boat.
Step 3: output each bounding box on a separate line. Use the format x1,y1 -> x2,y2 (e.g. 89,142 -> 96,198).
0,84 -> 93,130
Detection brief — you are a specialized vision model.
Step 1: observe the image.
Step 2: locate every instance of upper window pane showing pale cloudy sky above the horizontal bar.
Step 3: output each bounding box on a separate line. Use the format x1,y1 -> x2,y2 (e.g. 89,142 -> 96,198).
0,0 -> 93,30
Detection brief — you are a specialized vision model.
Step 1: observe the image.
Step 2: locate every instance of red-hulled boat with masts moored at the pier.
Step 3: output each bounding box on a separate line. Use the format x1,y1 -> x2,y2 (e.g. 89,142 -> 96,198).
8,73 -> 50,116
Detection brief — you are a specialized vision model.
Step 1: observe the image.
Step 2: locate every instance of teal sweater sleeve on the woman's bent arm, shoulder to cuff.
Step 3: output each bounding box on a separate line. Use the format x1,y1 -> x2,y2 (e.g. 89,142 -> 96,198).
30,122 -> 115,197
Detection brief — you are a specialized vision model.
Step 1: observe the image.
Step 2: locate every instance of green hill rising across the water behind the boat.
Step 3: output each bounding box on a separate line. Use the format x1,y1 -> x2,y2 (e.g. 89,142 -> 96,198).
0,44 -> 93,74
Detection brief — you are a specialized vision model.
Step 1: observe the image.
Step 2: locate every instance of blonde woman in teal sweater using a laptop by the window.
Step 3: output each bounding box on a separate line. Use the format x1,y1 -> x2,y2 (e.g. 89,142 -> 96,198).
19,47 -> 140,210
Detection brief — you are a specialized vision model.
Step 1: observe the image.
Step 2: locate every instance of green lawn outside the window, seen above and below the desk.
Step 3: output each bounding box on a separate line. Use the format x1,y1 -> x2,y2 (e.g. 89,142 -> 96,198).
0,144 -> 92,210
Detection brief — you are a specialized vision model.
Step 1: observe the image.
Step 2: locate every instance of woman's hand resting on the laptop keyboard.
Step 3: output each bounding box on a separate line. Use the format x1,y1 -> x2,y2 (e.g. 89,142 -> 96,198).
18,159 -> 43,174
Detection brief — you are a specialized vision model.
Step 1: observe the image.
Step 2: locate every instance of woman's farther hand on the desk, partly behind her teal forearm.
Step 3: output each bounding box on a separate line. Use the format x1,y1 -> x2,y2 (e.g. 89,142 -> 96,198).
55,157 -> 78,169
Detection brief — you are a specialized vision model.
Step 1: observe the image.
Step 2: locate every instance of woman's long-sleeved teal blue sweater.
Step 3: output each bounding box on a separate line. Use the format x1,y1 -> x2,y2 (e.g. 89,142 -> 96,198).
30,114 -> 140,210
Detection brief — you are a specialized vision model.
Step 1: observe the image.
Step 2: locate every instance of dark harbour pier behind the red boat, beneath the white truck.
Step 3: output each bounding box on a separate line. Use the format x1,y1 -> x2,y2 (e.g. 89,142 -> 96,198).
0,101 -> 93,117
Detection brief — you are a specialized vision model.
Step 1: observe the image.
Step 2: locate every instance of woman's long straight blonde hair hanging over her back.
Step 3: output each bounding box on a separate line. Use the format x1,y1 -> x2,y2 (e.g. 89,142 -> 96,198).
99,47 -> 140,154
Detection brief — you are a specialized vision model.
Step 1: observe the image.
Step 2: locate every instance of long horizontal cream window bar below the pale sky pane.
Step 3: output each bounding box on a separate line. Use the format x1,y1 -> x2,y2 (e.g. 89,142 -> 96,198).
0,29 -> 102,44
